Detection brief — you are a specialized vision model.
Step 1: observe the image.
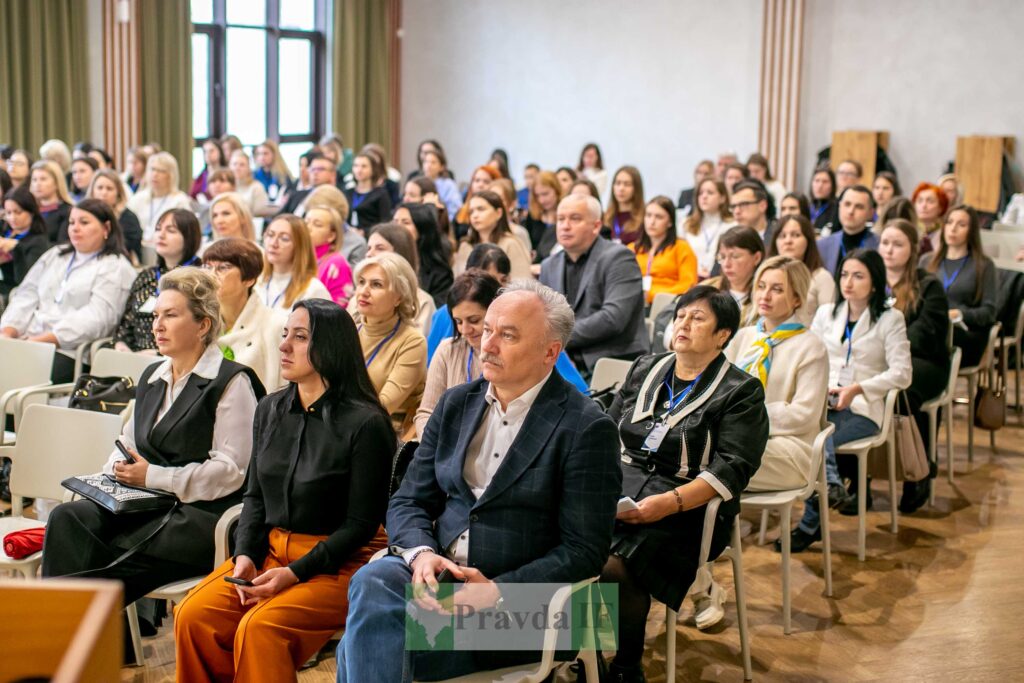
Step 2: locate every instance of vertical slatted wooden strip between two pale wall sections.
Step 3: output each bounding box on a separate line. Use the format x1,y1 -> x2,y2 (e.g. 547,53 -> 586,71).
758,0 -> 804,187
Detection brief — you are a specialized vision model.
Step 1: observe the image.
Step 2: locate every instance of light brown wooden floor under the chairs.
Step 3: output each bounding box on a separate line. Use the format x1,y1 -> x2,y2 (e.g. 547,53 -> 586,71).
28,408 -> 1024,683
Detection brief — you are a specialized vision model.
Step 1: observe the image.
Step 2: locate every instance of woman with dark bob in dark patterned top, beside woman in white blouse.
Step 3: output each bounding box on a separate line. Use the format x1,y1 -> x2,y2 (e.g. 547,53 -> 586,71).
114,209 -> 202,353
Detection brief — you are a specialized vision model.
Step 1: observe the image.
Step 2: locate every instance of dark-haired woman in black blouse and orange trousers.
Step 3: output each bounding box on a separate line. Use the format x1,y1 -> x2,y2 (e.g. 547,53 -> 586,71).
174,299 -> 396,681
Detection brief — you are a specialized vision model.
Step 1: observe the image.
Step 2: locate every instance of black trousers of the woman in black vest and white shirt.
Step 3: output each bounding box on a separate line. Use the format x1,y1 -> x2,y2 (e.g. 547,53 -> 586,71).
43,500 -> 210,605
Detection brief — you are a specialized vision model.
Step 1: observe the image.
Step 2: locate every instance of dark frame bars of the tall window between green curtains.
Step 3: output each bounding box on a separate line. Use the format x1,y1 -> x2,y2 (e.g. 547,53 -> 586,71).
191,0 -> 327,146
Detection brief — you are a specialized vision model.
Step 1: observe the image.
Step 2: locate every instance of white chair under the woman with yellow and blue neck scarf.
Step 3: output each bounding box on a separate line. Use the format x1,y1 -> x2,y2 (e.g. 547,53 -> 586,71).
739,424 -> 836,636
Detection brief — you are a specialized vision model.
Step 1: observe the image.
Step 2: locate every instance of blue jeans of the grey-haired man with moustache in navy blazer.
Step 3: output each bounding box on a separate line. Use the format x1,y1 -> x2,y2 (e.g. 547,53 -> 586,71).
337,556 -> 476,683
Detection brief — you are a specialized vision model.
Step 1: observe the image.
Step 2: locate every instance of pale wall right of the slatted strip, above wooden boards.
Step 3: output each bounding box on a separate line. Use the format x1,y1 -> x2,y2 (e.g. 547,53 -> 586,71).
800,0 -> 1024,191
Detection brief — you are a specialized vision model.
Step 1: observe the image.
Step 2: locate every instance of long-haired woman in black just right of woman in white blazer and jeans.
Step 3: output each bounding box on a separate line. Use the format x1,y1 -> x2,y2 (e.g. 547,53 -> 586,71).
879,219 -> 951,512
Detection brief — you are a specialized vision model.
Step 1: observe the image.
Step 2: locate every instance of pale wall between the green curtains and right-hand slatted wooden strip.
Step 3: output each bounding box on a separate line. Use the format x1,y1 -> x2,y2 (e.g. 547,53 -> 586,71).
400,0 -> 762,199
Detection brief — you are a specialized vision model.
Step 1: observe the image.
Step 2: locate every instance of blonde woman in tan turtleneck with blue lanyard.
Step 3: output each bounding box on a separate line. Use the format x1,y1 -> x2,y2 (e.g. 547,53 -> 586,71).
353,253 -> 427,440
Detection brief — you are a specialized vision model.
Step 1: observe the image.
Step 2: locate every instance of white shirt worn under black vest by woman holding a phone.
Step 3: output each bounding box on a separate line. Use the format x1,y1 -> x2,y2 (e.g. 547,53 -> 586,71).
103,343 -> 256,503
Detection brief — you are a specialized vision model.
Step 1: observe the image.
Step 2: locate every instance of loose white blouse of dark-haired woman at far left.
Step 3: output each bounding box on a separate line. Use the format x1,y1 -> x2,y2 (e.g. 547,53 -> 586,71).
0,245 -> 135,351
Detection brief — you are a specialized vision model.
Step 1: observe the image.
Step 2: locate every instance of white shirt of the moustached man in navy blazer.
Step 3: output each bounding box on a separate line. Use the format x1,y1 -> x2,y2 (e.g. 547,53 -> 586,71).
402,372 -> 551,565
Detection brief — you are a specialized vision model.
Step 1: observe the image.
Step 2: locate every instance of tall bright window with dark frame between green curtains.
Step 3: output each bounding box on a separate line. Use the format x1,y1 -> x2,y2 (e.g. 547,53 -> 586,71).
191,0 -> 327,174
